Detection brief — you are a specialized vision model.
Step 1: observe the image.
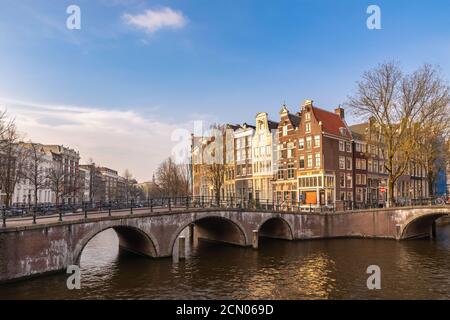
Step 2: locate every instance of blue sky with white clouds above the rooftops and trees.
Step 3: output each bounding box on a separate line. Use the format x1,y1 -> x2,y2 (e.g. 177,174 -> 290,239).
0,0 -> 450,181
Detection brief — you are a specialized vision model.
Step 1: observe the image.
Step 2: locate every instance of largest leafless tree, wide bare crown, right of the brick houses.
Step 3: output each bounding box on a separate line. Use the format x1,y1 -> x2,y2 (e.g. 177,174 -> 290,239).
347,62 -> 449,205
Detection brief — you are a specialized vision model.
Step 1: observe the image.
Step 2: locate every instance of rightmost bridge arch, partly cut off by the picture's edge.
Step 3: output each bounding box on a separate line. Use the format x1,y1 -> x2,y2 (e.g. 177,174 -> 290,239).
400,211 -> 448,239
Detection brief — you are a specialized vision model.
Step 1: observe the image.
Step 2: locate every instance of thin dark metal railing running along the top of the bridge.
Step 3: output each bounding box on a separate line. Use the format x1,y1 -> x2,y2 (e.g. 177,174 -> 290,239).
0,196 -> 445,228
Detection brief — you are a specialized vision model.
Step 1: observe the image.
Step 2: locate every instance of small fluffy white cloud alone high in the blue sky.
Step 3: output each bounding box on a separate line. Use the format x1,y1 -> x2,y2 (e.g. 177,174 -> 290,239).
123,7 -> 188,33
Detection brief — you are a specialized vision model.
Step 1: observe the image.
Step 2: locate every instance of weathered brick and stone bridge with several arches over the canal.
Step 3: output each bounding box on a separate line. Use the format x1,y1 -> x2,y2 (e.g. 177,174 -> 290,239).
0,206 -> 450,282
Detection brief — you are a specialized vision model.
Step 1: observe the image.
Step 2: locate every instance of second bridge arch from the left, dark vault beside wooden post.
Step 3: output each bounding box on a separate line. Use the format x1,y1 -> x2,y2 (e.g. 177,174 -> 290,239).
169,213 -> 250,254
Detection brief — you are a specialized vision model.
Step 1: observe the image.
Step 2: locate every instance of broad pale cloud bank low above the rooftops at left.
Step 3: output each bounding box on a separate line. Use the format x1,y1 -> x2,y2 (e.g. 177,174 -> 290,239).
0,98 -> 193,181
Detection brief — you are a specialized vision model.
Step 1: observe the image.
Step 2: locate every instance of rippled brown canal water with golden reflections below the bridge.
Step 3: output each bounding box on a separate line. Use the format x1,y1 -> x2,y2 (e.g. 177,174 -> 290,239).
0,224 -> 450,299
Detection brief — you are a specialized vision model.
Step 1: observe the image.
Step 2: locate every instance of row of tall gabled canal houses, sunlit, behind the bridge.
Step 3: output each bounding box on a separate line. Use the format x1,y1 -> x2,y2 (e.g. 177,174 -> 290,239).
192,100 -> 429,209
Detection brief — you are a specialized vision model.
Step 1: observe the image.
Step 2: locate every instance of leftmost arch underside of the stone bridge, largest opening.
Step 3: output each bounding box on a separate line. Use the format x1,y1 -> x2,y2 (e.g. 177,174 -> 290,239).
73,223 -> 159,265
